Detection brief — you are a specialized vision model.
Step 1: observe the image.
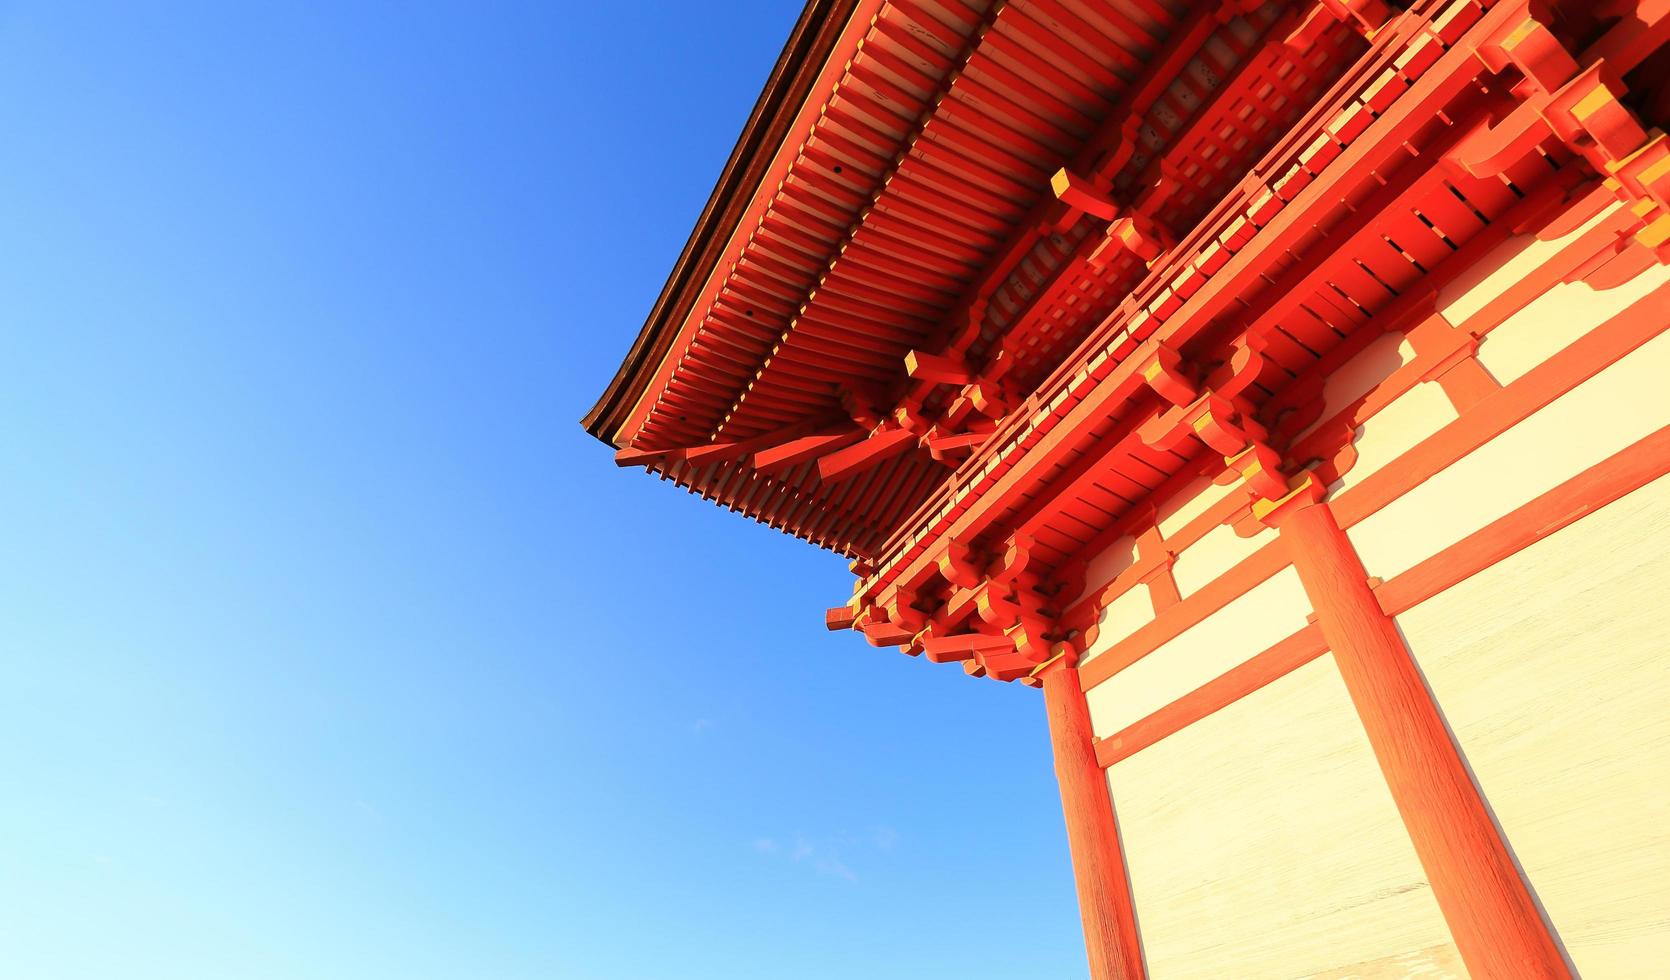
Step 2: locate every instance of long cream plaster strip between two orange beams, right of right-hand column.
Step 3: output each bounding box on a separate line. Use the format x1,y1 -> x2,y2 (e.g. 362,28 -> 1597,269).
1349,322 -> 1670,579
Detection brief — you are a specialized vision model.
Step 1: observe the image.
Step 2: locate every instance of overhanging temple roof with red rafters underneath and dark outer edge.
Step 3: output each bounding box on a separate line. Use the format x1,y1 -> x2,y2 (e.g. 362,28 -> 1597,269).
585,0 -> 1364,558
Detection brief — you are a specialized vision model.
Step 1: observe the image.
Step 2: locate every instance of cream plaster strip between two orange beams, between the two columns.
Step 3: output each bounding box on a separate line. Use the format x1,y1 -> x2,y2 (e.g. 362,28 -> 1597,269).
1086,568 -> 1311,738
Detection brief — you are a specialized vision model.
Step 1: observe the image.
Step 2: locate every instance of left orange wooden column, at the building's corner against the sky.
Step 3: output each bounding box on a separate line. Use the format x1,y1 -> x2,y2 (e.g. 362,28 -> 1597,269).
1044,664 -> 1142,980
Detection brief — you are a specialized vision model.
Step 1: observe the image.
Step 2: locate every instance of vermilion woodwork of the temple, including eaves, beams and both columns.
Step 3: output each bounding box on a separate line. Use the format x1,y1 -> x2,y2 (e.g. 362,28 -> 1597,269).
588,0 -> 1670,977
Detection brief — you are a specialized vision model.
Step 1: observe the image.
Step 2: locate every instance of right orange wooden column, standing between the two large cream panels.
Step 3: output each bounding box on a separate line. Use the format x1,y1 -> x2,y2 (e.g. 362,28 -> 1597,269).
1274,503 -> 1570,980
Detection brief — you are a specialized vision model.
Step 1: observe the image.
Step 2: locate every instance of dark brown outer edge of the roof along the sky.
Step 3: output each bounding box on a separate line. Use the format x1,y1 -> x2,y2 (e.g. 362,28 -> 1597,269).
579,0 -> 858,446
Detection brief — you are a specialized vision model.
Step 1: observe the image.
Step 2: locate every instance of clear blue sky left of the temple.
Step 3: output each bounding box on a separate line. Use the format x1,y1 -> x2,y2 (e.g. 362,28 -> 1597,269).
0,0 -> 1084,980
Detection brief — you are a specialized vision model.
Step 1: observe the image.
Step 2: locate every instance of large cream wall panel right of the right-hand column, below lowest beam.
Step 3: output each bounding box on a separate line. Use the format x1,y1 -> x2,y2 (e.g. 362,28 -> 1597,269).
1396,477 -> 1670,980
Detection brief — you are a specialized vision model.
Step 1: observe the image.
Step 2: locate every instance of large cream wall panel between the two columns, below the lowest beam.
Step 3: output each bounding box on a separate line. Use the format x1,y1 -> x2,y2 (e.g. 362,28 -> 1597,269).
1109,656 -> 1465,980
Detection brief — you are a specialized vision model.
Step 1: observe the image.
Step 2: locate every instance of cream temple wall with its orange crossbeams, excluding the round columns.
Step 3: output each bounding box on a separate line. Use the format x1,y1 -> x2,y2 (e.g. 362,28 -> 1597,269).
1080,181 -> 1670,978
